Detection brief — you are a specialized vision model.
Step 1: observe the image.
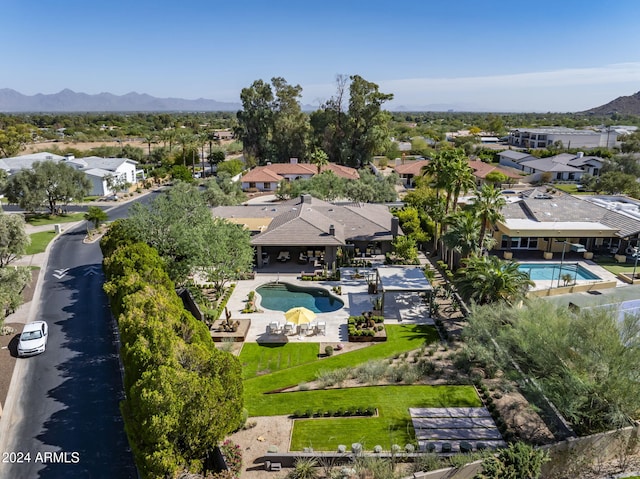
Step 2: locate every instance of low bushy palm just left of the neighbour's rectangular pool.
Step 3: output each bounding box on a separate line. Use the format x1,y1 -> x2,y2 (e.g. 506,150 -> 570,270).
454,256 -> 534,305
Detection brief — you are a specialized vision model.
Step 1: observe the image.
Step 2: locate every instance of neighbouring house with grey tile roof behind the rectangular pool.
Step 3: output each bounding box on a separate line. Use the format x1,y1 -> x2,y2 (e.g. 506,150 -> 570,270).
493,186 -> 640,253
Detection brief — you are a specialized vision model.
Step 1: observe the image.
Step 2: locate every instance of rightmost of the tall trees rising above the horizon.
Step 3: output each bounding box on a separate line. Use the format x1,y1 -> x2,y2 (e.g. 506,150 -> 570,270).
347,75 -> 393,166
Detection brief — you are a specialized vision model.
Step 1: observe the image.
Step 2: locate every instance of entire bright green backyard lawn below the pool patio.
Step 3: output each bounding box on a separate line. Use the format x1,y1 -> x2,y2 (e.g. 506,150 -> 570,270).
240,324 -> 481,450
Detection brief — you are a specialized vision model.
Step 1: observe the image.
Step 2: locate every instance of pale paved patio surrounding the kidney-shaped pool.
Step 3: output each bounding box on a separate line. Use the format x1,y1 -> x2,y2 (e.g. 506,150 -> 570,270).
227,268 -> 434,343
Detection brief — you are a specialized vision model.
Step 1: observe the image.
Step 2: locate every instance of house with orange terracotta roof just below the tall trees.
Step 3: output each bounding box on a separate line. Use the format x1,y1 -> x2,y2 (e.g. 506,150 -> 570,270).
240,162 -> 360,191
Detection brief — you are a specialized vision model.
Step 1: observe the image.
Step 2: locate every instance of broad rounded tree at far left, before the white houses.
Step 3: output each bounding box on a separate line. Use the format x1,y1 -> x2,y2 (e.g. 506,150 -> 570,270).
5,161 -> 91,214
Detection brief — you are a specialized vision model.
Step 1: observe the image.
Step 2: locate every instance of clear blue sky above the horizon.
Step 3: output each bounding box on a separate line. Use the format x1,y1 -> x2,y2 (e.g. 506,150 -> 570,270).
0,0 -> 640,112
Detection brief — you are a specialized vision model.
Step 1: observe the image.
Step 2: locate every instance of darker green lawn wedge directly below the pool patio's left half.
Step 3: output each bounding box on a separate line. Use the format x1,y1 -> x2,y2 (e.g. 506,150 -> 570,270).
240,343 -> 320,379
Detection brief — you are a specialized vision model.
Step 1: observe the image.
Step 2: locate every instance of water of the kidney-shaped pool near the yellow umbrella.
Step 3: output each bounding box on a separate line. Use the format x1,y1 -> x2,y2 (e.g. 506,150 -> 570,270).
256,283 -> 344,313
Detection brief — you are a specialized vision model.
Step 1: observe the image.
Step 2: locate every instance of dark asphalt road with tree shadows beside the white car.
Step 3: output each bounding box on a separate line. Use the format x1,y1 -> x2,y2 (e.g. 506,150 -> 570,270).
0,195 -> 159,479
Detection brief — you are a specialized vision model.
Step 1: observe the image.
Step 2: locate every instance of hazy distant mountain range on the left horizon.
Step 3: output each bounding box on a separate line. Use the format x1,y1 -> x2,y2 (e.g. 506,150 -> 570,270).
0,88 -> 242,113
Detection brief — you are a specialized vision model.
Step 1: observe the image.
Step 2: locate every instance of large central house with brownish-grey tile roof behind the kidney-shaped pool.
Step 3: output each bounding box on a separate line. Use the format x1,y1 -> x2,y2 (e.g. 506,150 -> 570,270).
212,195 -> 403,269
